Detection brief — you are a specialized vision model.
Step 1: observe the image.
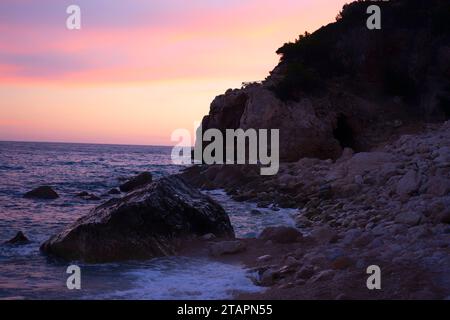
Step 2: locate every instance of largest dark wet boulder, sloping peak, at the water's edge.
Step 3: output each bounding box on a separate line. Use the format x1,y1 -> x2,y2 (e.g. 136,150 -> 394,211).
41,176 -> 234,263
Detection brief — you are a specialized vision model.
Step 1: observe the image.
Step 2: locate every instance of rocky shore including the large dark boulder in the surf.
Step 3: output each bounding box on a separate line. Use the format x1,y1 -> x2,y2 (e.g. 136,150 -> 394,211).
37,122 -> 450,299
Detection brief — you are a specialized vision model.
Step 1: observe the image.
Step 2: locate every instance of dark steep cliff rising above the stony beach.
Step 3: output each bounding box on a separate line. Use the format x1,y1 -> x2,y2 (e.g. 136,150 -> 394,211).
203,0 -> 450,161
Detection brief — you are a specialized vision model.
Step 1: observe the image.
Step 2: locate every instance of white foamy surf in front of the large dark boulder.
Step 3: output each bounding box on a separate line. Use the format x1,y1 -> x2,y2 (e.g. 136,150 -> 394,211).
88,257 -> 263,300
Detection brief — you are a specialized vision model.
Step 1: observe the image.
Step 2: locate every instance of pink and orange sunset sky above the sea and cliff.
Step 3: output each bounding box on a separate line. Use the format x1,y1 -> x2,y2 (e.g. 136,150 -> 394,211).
0,0 -> 349,145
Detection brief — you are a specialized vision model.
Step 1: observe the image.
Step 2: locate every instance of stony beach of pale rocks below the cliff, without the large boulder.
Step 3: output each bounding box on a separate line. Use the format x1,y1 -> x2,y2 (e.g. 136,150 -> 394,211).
179,122 -> 450,299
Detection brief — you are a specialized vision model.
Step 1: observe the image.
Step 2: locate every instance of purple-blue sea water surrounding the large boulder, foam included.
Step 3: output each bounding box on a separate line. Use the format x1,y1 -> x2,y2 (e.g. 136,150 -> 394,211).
0,142 -> 292,299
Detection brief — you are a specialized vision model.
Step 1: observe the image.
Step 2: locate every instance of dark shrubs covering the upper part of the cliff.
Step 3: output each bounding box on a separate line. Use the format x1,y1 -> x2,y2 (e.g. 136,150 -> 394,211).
271,0 -> 450,106
